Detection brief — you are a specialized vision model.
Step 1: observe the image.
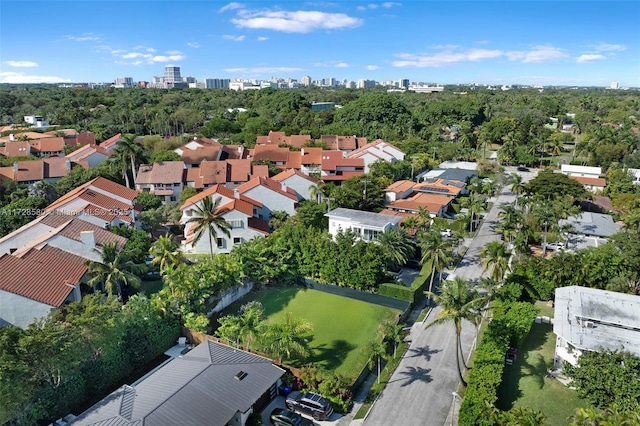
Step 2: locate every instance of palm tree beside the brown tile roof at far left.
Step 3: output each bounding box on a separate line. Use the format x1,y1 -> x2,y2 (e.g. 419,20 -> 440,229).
86,242 -> 144,299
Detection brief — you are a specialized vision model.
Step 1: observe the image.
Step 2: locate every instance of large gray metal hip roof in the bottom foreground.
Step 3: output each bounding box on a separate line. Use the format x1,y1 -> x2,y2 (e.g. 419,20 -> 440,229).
72,341 -> 284,426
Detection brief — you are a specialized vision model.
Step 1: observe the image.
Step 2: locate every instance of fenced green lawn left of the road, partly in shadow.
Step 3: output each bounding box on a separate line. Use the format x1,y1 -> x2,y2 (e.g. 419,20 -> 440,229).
212,287 -> 400,378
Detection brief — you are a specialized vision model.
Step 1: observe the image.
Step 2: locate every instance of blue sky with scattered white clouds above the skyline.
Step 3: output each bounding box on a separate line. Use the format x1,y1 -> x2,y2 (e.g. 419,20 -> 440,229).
0,0 -> 640,87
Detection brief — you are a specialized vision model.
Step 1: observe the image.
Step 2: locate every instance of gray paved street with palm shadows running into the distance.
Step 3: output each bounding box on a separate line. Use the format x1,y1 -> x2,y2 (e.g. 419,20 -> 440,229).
363,170 -> 535,426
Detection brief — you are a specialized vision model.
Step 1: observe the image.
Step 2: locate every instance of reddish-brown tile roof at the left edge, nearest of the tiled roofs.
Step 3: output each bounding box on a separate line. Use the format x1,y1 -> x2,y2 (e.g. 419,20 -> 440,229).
0,249 -> 87,307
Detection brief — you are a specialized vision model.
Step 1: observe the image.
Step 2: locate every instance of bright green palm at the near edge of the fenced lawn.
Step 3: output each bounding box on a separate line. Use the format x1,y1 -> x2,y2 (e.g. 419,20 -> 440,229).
263,312 -> 313,359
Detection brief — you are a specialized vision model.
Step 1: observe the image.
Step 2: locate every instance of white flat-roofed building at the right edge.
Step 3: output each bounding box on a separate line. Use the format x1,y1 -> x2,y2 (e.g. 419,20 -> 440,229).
553,286 -> 640,368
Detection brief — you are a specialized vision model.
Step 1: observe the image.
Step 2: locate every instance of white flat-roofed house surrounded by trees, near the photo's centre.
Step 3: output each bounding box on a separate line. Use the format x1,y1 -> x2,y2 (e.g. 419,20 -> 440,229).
325,207 -> 402,241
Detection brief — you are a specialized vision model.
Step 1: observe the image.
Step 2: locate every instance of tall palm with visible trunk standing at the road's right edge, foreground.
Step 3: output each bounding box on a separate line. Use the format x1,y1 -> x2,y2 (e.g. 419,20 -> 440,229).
427,277 -> 485,386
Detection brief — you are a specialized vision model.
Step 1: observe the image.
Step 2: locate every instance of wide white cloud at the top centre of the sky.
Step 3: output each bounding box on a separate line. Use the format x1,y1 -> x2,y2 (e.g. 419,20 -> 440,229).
231,10 -> 363,33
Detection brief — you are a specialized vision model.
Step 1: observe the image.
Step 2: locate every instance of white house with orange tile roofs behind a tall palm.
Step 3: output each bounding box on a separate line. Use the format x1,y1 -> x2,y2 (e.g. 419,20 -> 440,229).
180,185 -> 269,253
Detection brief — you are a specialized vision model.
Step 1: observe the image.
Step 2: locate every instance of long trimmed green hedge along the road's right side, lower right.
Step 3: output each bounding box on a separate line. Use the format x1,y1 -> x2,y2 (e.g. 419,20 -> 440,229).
459,301 -> 539,426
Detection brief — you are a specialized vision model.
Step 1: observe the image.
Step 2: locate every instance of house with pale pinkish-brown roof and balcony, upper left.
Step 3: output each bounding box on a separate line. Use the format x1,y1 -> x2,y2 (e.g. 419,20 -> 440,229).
136,161 -> 187,204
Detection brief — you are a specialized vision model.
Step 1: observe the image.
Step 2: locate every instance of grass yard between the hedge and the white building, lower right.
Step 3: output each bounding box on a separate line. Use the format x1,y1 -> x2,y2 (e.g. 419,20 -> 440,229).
496,322 -> 589,426
